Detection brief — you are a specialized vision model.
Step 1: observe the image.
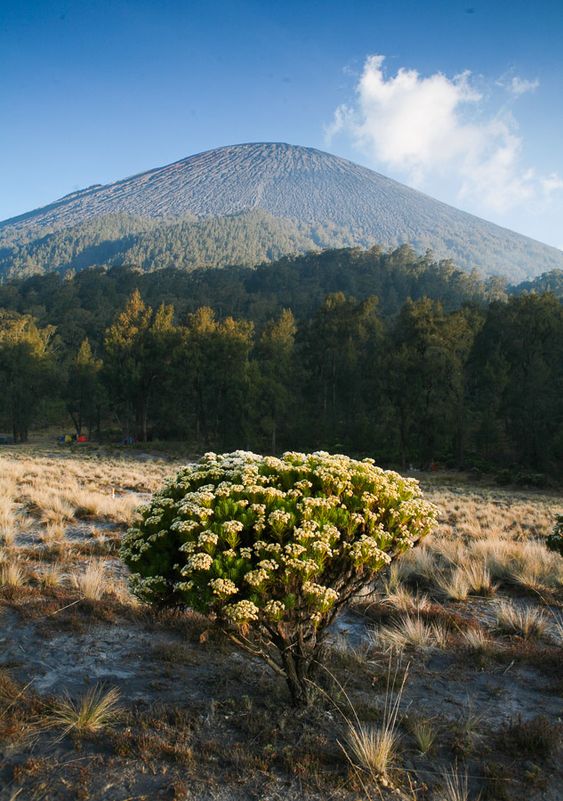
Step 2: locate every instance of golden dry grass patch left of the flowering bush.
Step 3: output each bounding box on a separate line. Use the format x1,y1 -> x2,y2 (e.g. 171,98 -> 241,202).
0,451 -> 159,605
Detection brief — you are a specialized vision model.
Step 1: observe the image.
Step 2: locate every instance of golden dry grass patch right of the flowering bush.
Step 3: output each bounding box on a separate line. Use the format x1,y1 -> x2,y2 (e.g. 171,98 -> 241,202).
393,478 -> 563,602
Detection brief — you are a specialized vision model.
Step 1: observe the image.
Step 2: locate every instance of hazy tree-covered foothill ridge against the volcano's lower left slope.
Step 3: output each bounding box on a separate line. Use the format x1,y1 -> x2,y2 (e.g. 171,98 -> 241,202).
0,209 -> 353,278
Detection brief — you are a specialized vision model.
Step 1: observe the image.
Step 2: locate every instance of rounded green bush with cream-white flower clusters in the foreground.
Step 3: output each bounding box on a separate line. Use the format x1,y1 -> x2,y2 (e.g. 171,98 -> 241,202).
121,451 -> 435,704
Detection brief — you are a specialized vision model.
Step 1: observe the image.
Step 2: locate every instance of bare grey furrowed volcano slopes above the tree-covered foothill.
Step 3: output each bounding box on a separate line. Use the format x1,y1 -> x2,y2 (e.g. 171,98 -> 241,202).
0,143 -> 563,280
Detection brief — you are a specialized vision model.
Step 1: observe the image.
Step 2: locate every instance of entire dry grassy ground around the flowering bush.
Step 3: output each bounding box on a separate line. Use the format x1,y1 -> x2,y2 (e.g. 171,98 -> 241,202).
0,448 -> 563,801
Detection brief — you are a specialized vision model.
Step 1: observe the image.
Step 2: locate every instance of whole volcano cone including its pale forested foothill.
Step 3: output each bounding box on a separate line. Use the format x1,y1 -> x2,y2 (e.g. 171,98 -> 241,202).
0,143 -> 563,282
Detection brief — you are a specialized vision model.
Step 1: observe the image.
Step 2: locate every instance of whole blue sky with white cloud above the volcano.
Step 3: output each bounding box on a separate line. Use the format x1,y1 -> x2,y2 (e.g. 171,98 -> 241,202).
0,0 -> 563,247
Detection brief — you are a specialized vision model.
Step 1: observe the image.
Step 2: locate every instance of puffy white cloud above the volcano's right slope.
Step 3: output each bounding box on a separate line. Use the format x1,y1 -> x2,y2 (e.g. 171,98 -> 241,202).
326,55 -> 563,212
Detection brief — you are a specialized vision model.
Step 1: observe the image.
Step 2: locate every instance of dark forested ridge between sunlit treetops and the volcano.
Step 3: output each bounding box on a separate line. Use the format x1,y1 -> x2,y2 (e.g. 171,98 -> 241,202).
0,245 -> 507,345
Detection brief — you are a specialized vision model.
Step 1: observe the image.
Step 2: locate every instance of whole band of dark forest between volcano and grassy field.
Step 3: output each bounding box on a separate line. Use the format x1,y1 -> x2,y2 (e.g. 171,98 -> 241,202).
0,246 -> 563,477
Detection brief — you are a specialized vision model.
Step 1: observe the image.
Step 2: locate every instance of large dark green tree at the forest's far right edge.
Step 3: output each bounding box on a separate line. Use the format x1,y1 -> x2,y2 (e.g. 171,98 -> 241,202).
468,293 -> 563,472
